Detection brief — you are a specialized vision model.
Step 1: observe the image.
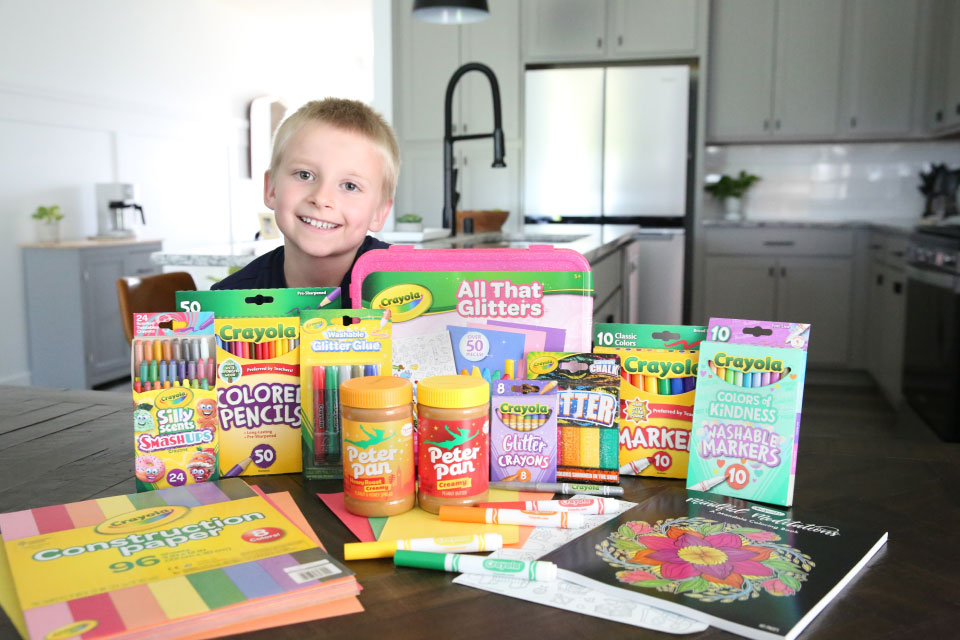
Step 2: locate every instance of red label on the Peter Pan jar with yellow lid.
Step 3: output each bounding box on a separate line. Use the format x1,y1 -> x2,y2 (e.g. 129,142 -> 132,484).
417,416 -> 490,498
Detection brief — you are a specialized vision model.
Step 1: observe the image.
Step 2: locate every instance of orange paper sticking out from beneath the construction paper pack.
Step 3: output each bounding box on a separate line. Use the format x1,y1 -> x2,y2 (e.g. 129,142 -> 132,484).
0,496 -> 363,640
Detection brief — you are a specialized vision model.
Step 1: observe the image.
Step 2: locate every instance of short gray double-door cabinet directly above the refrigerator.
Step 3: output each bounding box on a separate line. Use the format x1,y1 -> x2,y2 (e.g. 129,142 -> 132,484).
522,0 -> 707,62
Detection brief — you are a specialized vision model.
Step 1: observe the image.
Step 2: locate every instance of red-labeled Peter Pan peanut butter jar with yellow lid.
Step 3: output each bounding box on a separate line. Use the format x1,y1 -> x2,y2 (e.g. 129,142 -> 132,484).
417,376 -> 490,513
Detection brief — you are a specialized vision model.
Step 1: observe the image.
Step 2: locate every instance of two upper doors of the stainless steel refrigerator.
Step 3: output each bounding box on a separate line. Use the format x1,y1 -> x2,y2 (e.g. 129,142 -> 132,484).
523,65 -> 693,226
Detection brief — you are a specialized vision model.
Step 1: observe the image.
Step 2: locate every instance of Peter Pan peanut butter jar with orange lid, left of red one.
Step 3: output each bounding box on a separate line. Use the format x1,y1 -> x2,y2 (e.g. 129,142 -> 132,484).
340,376 -> 414,517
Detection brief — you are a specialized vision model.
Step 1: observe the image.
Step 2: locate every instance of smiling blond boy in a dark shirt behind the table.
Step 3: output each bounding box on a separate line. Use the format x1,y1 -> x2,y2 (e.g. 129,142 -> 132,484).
211,98 -> 400,307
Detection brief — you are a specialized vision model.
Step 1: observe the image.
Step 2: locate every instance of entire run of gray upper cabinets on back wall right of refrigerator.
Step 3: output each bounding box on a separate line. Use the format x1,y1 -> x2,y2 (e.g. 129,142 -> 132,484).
707,0 -> 922,142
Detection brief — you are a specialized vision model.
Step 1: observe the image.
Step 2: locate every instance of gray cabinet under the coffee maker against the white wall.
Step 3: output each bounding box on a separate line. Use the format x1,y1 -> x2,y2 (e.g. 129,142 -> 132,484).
23,241 -> 162,389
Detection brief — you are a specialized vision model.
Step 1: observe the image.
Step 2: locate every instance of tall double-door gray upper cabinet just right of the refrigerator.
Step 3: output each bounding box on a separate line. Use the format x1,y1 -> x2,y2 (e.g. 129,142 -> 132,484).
707,0 -> 843,142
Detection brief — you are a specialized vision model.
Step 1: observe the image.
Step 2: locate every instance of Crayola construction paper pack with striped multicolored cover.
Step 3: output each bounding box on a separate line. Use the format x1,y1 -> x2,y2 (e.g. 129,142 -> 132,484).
0,479 -> 358,640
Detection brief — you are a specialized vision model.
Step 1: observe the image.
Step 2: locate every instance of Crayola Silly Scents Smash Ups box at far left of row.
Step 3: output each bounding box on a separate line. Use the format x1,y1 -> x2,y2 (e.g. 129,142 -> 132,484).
130,313 -> 219,491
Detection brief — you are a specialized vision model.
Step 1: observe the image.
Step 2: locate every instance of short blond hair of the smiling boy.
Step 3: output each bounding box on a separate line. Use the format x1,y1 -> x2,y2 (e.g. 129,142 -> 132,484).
268,98 -> 400,202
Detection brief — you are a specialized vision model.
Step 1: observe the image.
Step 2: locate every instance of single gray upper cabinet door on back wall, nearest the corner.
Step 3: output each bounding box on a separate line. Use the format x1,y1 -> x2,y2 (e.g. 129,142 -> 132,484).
840,0 -> 920,138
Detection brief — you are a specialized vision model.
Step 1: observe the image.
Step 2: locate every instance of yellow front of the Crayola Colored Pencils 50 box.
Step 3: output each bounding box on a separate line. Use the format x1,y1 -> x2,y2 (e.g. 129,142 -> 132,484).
214,316 -> 301,477
